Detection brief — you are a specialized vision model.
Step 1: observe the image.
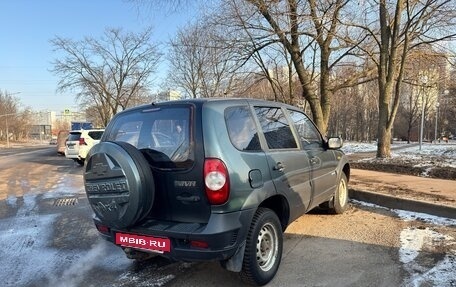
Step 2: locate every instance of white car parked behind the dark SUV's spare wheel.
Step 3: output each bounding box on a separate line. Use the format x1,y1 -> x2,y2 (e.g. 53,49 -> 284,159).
65,129 -> 104,165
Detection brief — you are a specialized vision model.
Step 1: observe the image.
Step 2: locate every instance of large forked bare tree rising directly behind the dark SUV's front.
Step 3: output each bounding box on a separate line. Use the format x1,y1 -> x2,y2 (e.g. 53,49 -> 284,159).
211,0 -> 374,133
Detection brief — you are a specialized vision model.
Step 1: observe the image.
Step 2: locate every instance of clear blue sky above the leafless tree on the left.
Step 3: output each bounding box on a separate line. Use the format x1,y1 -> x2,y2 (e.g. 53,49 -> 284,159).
0,0 -> 196,113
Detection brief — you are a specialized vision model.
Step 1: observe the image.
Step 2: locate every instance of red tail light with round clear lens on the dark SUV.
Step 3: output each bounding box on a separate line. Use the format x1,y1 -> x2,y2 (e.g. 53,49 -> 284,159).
204,158 -> 230,205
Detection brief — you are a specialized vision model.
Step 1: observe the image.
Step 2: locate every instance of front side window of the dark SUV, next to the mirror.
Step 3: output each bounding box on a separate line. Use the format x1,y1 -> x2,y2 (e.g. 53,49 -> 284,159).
289,110 -> 322,149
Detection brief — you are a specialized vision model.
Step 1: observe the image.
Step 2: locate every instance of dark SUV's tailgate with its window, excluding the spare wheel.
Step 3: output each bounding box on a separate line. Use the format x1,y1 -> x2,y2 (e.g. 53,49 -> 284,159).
106,104 -> 210,223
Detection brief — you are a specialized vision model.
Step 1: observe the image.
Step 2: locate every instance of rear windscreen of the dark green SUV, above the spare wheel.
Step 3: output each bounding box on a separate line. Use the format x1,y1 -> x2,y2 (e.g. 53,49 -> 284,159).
105,107 -> 193,168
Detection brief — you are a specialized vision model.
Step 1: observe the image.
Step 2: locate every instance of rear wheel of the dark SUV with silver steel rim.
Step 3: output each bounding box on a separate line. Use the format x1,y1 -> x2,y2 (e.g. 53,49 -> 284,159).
240,208 -> 283,286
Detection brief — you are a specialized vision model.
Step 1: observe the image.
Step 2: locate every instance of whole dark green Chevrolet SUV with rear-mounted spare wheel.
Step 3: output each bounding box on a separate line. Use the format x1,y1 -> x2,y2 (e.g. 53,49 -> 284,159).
84,99 -> 350,285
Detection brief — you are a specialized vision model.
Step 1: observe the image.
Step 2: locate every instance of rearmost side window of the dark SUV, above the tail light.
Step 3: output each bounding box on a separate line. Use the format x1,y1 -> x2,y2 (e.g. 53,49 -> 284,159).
225,106 -> 261,151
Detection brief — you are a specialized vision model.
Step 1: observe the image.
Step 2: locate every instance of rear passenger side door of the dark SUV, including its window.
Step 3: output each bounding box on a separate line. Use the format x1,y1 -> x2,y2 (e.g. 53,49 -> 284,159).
254,106 -> 311,220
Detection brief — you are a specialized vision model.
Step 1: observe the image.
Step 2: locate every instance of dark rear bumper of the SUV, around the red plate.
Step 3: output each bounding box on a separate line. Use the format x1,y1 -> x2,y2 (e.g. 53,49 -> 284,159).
94,209 -> 255,261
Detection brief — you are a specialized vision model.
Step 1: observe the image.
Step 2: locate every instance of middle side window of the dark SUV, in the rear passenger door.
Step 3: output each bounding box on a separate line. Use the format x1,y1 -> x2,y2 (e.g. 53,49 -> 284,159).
255,107 -> 297,149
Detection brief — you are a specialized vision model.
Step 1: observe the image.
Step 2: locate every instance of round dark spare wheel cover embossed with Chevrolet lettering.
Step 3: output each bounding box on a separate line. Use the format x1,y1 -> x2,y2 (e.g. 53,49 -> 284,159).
84,142 -> 155,228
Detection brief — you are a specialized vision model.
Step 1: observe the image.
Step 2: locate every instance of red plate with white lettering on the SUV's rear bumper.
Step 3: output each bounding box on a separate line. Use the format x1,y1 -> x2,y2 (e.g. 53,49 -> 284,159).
116,233 -> 171,253
